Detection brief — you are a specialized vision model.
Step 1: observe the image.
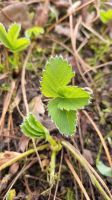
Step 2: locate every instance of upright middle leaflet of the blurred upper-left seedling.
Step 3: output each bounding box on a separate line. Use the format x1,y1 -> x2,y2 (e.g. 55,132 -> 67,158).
8,23 -> 21,42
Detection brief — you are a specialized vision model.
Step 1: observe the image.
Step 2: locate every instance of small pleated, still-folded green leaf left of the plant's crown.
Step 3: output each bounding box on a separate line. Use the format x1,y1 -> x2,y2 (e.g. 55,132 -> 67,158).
20,113 -> 45,138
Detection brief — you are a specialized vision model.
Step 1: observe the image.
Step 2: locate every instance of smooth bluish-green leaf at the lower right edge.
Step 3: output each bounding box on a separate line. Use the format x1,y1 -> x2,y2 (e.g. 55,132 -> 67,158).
96,161 -> 112,177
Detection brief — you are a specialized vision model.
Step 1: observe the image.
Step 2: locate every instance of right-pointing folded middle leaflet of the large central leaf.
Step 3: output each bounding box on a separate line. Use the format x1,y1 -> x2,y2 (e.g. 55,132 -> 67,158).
57,86 -> 90,110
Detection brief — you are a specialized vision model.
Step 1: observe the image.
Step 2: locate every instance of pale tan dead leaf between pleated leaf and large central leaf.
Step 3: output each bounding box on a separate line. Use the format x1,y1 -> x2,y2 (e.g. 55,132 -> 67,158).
29,95 -> 45,121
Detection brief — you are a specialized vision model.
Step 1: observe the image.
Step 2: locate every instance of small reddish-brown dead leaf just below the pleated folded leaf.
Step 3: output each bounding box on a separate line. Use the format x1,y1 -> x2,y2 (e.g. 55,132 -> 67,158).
19,135 -> 29,152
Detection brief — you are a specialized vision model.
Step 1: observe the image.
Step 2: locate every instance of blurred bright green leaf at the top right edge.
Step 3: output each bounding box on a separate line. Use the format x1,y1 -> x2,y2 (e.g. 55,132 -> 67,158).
100,9 -> 112,24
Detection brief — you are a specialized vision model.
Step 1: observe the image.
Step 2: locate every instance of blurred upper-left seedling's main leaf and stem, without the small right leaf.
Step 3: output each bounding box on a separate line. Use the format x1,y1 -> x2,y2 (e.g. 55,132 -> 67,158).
0,23 -> 30,73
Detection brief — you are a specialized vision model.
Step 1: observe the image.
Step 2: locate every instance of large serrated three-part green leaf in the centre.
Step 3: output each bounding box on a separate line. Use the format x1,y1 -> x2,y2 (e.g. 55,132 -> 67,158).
41,56 -> 91,136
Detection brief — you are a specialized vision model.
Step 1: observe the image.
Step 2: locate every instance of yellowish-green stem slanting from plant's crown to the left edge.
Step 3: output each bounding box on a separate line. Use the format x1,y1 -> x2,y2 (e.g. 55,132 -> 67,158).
0,144 -> 49,171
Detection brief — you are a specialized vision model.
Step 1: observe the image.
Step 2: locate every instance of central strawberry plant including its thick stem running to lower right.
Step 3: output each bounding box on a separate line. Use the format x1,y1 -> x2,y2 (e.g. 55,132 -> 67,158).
21,56 -> 111,200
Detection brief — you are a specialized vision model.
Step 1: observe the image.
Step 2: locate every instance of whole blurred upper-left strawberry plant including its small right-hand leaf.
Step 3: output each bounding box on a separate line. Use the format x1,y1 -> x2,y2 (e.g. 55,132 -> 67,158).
0,23 -> 44,72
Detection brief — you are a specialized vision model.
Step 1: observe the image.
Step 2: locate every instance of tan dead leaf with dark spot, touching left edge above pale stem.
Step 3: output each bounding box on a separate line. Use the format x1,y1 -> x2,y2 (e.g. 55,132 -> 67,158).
0,151 -> 20,166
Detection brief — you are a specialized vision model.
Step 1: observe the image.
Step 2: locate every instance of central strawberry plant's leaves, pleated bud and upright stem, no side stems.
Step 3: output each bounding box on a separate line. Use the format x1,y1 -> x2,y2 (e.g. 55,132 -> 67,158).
21,57 -> 90,185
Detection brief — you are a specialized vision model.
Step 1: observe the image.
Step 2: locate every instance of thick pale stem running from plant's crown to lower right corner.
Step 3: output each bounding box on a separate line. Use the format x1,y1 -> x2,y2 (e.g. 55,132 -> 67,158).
61,141 -> 111,200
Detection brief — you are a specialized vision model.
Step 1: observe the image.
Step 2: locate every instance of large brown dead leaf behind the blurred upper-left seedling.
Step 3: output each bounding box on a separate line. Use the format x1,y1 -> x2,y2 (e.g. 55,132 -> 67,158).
0,2 -> 31,29
